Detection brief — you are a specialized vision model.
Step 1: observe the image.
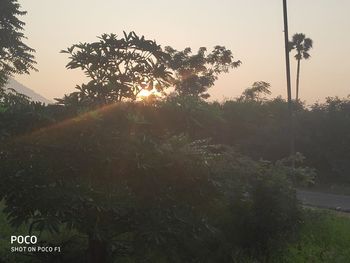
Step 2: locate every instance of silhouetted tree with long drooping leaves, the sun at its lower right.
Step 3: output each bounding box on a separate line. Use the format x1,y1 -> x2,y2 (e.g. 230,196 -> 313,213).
58,32 -> 171,105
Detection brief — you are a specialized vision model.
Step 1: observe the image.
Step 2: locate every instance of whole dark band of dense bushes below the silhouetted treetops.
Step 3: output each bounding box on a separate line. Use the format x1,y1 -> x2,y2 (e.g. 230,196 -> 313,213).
0,92 -> 349,262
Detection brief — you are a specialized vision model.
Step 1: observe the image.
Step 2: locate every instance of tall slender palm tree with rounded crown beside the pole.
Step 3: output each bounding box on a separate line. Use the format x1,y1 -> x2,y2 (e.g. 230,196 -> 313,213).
289,33 -> 313,101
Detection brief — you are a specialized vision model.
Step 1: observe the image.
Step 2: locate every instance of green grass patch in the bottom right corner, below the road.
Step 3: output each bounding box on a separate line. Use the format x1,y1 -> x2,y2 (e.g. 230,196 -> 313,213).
273,209 -> 350,263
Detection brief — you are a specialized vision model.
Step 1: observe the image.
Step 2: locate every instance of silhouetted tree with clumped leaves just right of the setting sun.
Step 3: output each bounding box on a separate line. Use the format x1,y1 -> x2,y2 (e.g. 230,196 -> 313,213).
165,46 -> 241,98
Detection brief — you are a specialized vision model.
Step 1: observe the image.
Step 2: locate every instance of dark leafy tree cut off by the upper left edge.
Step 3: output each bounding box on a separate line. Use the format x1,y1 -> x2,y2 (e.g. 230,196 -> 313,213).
0,0 -> 36,88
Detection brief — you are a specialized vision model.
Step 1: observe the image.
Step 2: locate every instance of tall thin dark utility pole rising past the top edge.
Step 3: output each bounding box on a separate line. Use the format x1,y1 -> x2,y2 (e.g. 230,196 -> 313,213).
283,0 -> 295,168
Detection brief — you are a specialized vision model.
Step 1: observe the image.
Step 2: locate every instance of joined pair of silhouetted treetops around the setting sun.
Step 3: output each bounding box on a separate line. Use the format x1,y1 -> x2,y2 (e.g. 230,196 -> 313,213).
57,32 -> 241,105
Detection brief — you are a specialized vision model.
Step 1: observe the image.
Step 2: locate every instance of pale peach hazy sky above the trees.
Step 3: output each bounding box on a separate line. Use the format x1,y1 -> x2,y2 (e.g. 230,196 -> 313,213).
16,0 -> 350,103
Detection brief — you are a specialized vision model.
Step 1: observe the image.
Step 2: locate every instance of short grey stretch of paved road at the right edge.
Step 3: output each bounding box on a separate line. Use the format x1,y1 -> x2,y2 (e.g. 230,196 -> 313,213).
297,190 -> 350,212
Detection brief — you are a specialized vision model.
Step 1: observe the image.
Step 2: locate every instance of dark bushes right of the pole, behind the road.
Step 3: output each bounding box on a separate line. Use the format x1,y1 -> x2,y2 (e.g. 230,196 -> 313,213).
297,97 -> 350,184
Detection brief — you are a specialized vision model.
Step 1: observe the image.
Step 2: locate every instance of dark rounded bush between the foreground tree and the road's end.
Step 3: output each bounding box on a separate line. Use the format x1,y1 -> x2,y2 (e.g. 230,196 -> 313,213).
204,151 -> 300,262
